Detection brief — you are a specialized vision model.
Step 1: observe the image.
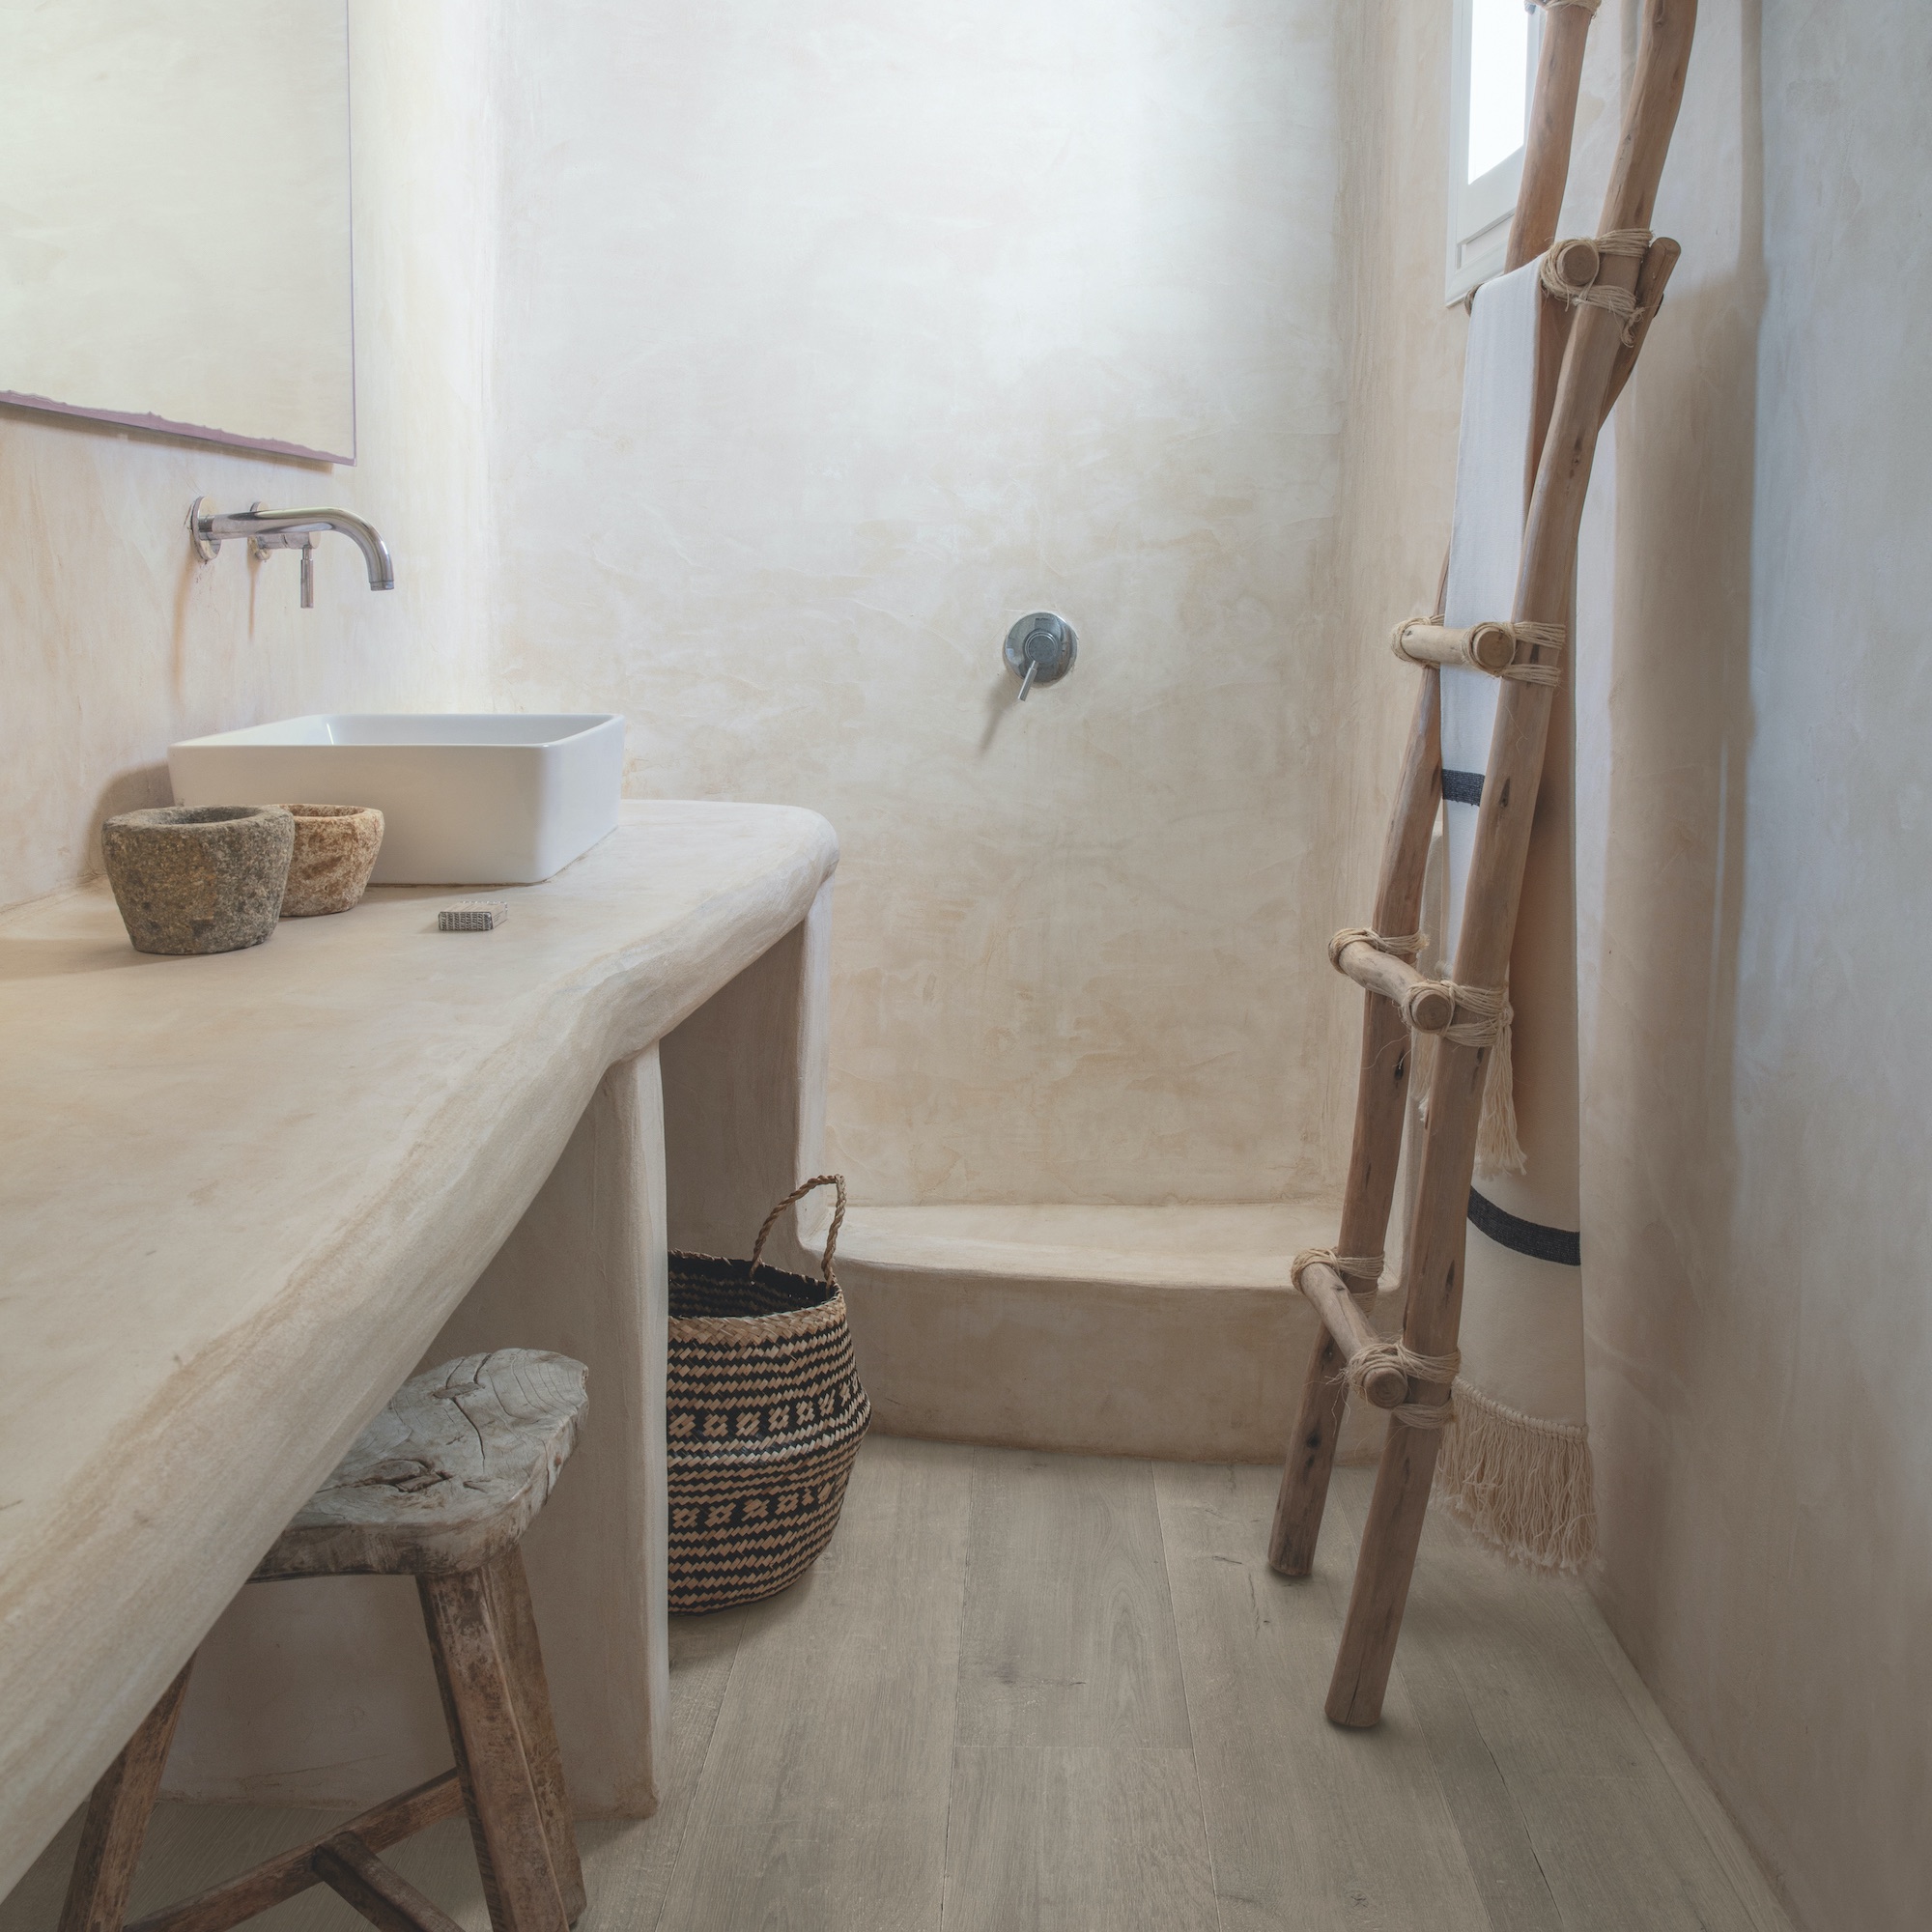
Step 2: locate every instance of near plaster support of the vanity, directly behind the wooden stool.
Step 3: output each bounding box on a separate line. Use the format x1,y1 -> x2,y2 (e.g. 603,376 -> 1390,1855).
168,1047 -> 668,1818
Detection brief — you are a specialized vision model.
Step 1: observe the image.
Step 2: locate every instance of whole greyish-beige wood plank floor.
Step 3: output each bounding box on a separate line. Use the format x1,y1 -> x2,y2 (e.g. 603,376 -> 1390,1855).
0,1437 -> 1789,1932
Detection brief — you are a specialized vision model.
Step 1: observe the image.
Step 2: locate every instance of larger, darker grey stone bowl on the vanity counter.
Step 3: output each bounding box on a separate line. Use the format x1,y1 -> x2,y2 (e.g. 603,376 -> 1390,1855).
100,806 -> 296,952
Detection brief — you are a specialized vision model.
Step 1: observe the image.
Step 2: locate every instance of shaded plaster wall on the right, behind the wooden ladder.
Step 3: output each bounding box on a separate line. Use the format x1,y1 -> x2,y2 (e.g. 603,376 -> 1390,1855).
1578,0 -> 1932,1932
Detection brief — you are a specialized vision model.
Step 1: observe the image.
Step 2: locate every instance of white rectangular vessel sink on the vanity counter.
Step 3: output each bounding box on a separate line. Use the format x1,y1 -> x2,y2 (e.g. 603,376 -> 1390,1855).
168,711 -> 624,885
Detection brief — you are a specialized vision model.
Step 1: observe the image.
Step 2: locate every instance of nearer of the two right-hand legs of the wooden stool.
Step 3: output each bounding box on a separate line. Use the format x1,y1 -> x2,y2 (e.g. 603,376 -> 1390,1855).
415,1569 -> 566,1932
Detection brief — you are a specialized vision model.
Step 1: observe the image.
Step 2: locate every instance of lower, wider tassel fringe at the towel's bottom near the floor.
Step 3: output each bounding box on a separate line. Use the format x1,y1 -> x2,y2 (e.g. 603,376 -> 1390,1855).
1435,1376 -> 1596,1571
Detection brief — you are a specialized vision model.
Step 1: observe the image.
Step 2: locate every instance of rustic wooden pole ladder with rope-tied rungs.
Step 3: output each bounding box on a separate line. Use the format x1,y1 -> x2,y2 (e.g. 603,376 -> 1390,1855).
1267,0 -> 1696,1727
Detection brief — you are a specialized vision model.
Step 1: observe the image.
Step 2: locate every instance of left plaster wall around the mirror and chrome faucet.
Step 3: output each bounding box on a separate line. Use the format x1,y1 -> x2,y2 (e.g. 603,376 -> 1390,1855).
0,0 -> 495,904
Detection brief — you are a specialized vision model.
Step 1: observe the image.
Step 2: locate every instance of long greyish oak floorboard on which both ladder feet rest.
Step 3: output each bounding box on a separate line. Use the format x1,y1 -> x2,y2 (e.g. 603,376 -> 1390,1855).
1155,1463 -> 1490,1932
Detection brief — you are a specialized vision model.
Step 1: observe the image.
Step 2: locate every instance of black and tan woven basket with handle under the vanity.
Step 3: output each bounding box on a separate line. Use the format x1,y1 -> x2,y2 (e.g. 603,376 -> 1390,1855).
667,1175 -> 871,1611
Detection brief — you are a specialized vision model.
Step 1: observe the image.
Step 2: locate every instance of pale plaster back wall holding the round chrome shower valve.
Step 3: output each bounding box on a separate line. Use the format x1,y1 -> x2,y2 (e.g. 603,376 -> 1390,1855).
483,0 -> 1350,1202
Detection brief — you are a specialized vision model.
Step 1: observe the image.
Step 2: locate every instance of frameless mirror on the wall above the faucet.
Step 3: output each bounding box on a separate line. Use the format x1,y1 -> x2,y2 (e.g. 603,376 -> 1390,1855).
0,0 -> 355,462
